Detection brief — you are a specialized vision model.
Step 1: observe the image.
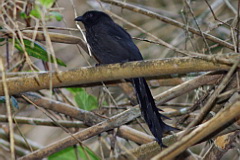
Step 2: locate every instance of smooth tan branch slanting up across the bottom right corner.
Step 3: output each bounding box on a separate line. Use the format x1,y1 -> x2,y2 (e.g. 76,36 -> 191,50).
153,95 -> 240,160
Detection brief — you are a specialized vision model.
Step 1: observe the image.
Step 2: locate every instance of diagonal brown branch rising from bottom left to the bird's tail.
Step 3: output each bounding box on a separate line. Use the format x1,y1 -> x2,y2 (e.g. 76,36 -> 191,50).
19,107 -> 139,160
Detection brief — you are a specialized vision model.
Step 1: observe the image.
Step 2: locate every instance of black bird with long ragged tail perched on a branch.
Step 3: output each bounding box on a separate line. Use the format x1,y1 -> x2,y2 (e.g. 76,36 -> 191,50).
75,11 -> 176,147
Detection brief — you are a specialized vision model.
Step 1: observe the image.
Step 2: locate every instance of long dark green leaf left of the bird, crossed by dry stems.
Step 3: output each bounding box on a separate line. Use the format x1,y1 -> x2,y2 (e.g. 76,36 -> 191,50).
15,39 -> 67,67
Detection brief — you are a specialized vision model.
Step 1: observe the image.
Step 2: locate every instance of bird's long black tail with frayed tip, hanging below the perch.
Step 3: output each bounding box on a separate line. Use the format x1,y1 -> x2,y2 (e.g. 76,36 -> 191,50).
132,78 -> 177,147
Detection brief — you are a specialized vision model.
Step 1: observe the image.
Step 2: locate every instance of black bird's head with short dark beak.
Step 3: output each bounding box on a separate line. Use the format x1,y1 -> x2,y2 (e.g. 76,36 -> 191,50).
74,11 -> 112,27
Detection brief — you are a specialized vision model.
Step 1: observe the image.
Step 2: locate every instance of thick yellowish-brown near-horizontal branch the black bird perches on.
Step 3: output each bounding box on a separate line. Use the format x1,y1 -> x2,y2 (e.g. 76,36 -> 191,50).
0,54 -> 238,96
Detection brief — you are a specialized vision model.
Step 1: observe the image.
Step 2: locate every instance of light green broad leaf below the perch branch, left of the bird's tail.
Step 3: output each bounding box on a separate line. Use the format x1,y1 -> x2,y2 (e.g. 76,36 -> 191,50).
68,88 -> 98,111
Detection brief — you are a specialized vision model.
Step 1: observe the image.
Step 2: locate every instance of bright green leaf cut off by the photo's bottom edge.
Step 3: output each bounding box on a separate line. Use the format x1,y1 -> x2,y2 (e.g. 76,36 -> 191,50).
48,146 -> 100,160
